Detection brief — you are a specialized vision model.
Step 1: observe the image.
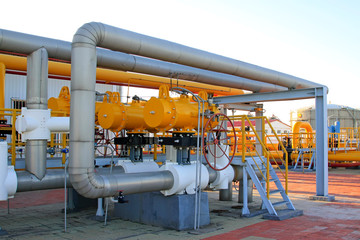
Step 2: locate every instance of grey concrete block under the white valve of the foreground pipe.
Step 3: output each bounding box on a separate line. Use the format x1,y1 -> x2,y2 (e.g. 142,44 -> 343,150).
114,192 -> 210,230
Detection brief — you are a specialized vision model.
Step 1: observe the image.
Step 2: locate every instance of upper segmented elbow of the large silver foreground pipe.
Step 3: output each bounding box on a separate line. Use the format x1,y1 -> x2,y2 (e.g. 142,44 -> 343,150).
73,22 -> 105,47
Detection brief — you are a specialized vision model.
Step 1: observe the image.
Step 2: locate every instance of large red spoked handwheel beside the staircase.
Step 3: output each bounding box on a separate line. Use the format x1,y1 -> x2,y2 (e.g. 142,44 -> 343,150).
202,113 -> 236,171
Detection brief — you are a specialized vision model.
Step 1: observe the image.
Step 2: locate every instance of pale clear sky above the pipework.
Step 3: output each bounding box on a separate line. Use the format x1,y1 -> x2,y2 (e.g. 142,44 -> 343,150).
0,0 -> 360,122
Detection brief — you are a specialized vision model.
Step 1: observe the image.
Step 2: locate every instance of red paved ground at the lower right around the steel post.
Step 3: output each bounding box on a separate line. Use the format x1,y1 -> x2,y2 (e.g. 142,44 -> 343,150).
206,170 -> 360,240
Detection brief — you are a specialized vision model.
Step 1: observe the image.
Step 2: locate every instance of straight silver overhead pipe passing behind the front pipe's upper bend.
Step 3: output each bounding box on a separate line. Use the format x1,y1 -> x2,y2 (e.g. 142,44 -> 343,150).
0,27 -> 287,92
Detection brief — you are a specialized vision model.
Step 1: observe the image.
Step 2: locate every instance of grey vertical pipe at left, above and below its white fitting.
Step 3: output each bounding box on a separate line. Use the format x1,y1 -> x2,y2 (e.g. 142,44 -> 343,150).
25,48 -> 48,180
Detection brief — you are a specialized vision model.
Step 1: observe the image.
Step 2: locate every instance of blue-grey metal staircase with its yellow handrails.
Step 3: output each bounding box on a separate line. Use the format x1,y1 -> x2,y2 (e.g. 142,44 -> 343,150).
228,115 -> 302,220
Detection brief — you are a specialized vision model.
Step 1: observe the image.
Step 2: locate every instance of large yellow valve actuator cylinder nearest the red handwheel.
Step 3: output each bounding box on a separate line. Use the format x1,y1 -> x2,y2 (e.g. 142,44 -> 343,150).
144,85 -> 218,132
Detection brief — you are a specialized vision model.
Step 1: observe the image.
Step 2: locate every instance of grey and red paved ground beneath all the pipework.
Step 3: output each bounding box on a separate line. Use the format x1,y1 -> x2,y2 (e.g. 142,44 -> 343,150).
0,169 -> 360,240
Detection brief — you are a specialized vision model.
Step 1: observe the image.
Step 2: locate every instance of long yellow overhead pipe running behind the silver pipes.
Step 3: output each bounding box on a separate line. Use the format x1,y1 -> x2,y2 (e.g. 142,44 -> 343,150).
0,54 -> 244,96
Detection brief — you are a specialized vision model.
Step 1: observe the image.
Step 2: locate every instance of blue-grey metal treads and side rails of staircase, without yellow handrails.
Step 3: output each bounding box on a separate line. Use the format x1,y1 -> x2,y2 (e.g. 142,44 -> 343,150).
244,157 -> 295,216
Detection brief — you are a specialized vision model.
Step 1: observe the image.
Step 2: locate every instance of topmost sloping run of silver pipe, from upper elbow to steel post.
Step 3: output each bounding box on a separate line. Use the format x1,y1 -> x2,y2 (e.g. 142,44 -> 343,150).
82,22 -> 321,89
